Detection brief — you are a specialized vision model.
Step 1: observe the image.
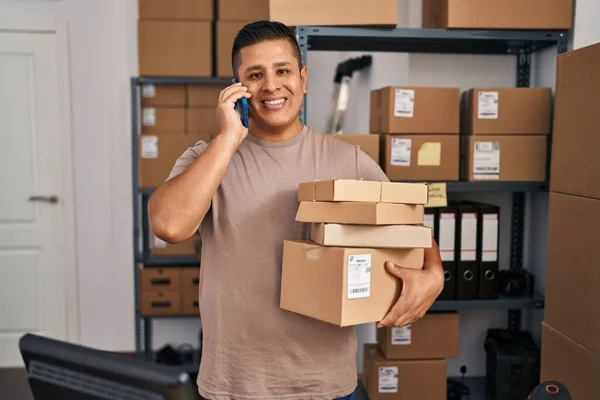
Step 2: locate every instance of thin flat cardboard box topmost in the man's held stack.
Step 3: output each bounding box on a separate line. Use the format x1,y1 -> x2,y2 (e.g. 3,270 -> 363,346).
298,179 -> 429,204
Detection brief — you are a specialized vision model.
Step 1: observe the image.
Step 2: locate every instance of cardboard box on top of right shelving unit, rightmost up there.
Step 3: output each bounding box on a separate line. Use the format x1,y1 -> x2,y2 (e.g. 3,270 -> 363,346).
422,0 -> 573,29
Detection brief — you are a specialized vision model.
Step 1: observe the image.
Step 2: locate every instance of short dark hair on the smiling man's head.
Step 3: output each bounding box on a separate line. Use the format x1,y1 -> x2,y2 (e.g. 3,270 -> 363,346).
231,21 -> 302,77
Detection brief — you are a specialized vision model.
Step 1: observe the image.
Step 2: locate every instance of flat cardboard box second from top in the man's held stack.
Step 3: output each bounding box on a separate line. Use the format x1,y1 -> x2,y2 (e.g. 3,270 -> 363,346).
296,201 -> 425,225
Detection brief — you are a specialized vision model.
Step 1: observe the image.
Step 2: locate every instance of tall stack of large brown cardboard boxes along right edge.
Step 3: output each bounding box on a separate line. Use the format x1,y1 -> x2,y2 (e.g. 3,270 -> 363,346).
541,44 -> 600,399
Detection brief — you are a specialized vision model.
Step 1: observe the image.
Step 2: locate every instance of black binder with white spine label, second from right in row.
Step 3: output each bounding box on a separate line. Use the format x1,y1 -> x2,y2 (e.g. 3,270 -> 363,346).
456,202 -> 479,300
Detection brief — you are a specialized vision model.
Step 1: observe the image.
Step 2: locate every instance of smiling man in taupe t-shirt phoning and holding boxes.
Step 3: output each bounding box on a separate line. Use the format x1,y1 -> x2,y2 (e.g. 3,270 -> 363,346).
149,21 -> 443,400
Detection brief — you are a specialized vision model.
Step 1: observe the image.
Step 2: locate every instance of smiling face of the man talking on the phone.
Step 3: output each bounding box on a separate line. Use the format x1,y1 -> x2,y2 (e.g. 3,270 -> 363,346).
238,39 -> 306,131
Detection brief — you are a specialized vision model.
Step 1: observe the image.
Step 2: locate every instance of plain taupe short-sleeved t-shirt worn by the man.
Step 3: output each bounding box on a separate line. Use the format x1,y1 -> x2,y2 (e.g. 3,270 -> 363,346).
170,126 -> 388,400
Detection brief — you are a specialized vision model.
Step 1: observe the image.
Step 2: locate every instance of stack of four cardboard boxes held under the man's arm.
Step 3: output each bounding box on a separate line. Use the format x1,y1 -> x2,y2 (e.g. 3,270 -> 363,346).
280,180 -> 432,326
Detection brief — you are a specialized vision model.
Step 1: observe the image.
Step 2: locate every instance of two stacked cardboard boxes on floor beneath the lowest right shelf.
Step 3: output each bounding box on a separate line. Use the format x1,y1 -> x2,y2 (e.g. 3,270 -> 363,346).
362,312 -> 460,400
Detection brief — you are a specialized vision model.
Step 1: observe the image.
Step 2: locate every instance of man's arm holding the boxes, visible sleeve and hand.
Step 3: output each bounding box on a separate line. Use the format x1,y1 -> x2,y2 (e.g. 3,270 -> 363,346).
357,150 -> 444,328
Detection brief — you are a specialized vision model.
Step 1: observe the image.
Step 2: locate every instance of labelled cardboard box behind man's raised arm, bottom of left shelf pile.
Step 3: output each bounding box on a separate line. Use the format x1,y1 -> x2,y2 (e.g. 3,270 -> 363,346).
138,133 -> 205,188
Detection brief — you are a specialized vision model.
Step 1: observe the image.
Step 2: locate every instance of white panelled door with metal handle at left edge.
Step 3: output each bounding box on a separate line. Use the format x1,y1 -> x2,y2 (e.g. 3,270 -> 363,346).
0,31 -> 69,367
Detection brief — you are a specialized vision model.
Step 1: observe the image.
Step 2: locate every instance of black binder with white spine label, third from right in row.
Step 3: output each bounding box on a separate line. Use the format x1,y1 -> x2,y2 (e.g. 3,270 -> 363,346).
437,205 -> 457,300
